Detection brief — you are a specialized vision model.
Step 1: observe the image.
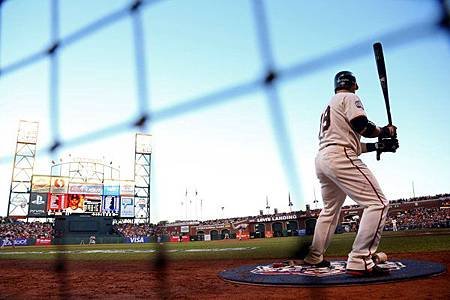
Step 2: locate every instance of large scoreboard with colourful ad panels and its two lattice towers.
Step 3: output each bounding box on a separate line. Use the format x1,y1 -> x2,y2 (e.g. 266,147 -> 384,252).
7,121 -> 152,222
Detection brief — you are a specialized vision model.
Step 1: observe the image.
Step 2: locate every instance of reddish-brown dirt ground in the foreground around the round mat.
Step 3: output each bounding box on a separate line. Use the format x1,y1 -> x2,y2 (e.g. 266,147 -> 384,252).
0,251 -> 450,300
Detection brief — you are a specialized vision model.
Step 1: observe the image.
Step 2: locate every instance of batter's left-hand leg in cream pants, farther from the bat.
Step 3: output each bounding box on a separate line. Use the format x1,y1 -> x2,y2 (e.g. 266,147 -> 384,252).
304,155 -> 346,264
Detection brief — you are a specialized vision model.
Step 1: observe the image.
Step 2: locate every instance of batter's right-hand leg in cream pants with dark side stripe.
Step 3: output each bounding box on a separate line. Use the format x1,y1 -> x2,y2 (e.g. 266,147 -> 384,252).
338,149 -> 389,270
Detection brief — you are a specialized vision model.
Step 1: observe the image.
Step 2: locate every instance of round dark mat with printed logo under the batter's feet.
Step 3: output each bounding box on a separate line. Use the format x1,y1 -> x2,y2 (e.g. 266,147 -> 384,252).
219,259 -> 446,286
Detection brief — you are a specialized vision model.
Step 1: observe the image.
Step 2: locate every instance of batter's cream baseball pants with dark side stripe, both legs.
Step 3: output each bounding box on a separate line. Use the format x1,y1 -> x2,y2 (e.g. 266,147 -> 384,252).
305,145 -> 389,270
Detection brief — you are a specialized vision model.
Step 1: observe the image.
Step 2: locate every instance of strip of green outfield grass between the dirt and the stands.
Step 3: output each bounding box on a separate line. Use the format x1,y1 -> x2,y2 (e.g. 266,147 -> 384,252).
0,229 -> 450,260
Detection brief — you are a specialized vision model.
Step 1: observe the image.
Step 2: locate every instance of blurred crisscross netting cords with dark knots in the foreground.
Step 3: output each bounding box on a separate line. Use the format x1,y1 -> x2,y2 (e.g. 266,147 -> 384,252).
0,0 -> 450,298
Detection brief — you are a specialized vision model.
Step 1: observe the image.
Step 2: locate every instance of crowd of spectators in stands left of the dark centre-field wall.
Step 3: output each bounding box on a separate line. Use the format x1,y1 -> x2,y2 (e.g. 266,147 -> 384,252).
0,217 -> 53,239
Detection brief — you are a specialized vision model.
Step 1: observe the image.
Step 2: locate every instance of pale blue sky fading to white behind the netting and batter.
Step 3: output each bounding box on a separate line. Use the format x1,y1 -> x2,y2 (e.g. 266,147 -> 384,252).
0,0 -> 450,221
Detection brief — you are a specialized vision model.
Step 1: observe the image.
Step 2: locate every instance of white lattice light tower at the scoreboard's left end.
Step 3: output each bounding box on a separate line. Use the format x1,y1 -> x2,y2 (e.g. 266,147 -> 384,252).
7,121 -> 39,217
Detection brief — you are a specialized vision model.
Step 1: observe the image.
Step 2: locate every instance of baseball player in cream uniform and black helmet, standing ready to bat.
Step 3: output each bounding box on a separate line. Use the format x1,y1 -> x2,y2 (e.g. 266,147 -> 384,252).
304,71 -> 398,276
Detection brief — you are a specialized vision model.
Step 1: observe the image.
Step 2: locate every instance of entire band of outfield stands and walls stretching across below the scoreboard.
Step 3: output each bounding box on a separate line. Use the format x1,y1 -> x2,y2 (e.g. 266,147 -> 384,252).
0,194 -> 450,246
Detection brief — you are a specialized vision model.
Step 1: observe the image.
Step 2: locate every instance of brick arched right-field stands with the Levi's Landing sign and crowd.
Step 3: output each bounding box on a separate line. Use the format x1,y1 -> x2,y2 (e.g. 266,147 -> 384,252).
160,194 -> 450,242
